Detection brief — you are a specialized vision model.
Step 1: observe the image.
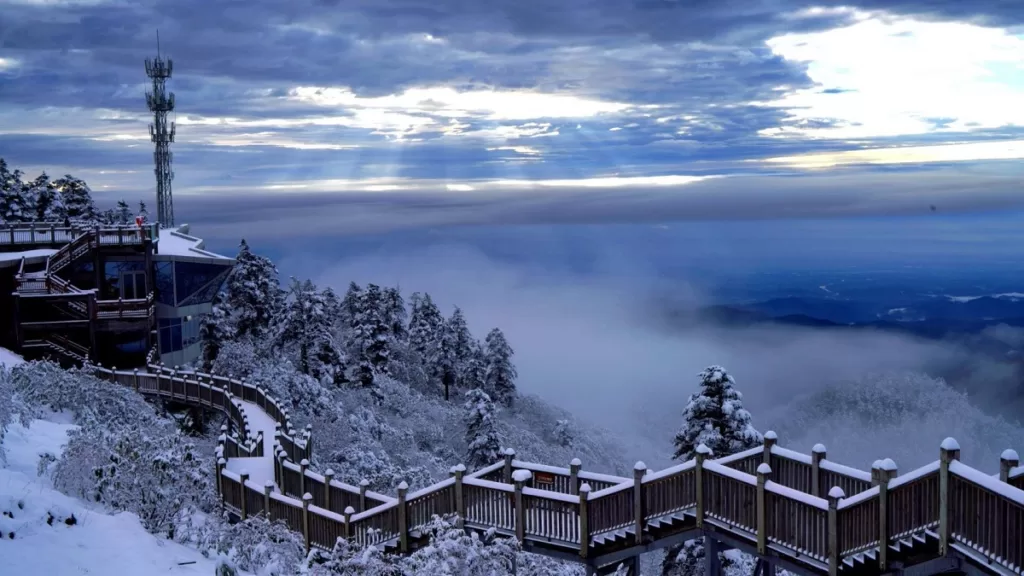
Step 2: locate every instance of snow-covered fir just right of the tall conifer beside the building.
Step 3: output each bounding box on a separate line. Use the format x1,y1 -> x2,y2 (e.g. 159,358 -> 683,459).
278,278 -> 345,383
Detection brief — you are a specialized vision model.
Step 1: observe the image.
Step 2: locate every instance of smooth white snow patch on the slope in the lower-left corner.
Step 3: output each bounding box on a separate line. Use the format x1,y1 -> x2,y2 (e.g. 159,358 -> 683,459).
0,414 -> 224,576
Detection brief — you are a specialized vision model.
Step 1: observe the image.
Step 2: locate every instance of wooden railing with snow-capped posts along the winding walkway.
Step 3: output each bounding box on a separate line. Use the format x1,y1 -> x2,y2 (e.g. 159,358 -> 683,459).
75,354 -> 1024,572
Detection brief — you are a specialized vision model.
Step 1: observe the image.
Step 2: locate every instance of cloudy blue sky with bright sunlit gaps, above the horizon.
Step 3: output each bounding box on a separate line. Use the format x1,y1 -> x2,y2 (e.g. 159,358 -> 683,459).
0,0 -> 1024,237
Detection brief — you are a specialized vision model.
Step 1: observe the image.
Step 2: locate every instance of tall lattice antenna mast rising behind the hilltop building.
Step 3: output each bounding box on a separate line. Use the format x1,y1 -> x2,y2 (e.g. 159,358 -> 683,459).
145,31 -> 174,227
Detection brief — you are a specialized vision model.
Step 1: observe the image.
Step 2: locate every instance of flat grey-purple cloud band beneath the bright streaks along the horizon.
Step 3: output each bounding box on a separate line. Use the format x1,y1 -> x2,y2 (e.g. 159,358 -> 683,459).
159,165 -> 1024,239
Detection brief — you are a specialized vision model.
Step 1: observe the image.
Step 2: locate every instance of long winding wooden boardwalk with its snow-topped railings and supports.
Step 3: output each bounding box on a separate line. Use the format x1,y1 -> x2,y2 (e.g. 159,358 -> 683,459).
86,358 -> 1024,576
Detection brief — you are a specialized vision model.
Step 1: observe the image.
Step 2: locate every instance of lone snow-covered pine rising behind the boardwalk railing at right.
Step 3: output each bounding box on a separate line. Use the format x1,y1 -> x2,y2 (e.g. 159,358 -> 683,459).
662,366 -> 763,576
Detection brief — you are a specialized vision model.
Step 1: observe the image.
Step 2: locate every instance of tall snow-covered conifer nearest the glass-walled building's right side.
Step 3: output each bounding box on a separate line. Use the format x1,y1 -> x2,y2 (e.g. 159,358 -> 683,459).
225,239 -> 284,337
